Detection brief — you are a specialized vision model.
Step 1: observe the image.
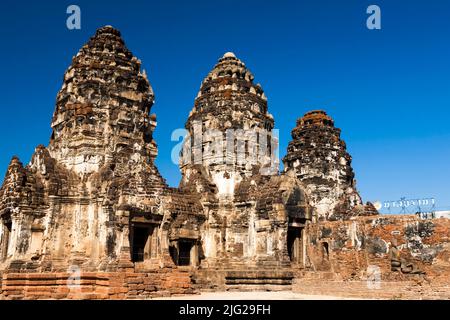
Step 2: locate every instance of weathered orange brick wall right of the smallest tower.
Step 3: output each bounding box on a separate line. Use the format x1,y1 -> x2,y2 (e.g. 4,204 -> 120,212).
306,215 -> 450,284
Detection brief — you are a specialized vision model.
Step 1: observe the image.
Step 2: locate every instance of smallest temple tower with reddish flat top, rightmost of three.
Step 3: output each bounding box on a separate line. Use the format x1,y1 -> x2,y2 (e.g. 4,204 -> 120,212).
283,110 -> 362,219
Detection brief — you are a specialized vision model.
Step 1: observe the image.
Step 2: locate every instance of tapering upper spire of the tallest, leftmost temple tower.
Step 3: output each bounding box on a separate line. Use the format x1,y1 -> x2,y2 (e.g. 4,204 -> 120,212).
49,26 -> 157,175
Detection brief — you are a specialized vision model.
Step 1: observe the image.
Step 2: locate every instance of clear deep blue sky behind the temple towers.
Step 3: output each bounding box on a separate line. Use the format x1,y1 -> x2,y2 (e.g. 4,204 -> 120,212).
0,0 -> 450,207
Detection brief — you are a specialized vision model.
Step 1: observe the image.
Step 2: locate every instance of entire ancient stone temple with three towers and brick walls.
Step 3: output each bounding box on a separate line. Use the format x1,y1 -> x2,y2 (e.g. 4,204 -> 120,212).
0,26 -> 450,299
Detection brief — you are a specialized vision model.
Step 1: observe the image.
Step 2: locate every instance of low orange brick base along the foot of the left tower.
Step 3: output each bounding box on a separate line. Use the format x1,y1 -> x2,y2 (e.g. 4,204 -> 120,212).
0,269 -> 195,299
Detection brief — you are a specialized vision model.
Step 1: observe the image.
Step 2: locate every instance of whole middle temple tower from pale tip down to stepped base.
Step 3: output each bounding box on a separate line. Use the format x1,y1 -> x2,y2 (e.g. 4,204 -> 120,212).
180,52 -> 311,285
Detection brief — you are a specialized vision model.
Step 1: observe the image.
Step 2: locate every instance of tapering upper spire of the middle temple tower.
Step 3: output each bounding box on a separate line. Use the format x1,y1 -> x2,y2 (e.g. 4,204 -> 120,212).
180,52 -> 278,198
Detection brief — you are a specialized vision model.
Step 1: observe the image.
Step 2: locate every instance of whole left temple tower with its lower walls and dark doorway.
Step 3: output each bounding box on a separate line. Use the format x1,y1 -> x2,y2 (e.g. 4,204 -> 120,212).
0,26 -> 170,270
